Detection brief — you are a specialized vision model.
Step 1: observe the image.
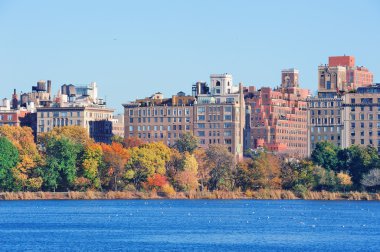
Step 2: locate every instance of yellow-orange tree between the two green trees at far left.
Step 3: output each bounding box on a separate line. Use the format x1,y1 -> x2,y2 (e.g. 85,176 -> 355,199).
0,125 -> 43,191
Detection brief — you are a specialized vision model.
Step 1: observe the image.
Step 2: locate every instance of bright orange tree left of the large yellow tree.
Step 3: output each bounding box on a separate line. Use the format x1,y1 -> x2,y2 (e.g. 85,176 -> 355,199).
101,142 -> 130,191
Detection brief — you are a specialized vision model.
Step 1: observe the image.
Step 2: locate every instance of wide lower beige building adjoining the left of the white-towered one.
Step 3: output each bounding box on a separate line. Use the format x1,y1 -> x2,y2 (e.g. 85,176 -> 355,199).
123,92 -> 194,146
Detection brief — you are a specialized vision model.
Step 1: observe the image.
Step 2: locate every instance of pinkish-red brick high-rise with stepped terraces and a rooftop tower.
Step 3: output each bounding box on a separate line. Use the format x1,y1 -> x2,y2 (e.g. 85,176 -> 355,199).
245,69 -> 309,157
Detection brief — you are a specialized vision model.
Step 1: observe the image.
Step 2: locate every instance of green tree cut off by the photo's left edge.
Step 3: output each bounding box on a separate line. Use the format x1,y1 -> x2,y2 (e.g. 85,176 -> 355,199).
0,137 -> 19,191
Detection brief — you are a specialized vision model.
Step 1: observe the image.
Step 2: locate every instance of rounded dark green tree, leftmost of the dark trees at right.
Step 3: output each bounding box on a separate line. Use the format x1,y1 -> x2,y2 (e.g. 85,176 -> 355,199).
311,141 -> 339,170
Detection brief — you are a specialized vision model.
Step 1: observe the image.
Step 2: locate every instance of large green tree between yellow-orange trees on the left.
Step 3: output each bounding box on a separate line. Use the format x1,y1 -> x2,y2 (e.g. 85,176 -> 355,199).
41,137 -> 82,191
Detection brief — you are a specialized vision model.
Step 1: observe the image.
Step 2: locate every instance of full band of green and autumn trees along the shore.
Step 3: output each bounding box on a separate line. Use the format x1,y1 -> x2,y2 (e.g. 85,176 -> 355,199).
0,126 -> 380,195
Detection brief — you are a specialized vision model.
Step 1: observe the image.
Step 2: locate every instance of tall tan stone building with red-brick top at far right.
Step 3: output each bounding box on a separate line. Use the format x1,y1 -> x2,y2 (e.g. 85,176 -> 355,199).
308,56 -> 379,155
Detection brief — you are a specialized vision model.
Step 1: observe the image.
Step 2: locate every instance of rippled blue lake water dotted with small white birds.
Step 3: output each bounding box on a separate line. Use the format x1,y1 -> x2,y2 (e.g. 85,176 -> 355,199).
0,200 -> 380,251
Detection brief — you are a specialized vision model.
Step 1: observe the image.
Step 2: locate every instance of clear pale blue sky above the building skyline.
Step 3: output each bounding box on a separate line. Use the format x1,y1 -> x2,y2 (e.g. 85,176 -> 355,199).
0,0 -> 380,112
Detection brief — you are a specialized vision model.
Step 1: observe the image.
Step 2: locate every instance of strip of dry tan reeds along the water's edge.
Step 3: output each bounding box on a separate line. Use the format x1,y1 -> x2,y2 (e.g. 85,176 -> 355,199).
0,189 -> 380,201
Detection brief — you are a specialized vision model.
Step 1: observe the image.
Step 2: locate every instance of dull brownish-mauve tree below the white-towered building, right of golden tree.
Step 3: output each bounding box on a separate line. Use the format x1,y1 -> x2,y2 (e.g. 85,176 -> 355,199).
206,144 -> 235,190
